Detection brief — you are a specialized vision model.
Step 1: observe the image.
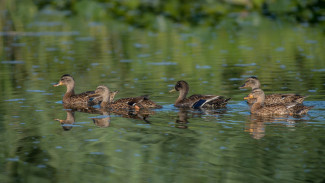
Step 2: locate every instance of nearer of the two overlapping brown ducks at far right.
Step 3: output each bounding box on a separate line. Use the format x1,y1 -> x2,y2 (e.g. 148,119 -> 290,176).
244,88 -> 314,116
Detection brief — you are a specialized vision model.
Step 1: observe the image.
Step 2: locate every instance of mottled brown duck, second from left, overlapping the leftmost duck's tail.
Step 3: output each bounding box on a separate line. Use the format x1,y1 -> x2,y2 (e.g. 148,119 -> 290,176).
89,85 -> 162,110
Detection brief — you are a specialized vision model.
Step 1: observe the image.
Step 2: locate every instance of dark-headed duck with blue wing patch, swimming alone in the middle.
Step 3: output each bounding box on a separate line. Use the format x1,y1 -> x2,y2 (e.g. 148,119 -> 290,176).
169,80 -> 231,109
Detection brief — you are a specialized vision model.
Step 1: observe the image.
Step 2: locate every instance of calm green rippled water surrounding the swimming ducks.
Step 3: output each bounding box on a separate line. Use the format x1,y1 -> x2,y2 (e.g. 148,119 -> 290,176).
0,4 -> 325,183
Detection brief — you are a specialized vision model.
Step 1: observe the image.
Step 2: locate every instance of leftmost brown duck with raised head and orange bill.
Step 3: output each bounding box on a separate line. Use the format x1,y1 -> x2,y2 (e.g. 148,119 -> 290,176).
53,74 -> 102,105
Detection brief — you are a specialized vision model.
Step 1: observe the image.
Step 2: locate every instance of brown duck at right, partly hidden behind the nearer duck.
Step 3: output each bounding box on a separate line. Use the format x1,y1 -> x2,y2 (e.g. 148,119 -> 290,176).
239,76 -> 306,105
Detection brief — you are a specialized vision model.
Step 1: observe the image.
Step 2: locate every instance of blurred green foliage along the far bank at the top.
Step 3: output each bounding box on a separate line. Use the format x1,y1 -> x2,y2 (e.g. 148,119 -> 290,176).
28,0 -> 325,27
